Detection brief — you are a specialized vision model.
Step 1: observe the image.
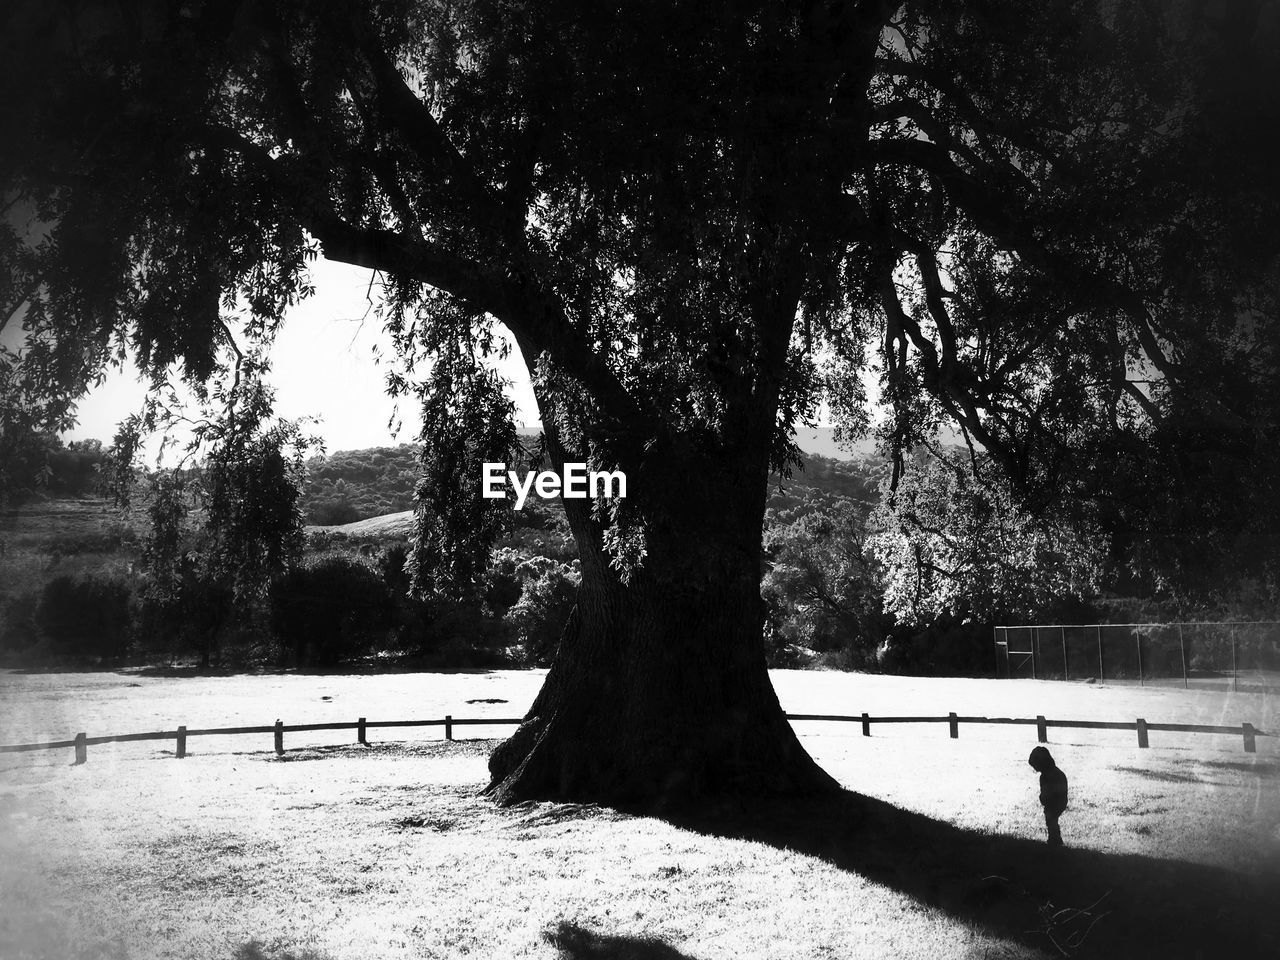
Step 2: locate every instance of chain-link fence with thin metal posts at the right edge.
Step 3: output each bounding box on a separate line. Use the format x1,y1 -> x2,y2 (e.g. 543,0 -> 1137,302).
995,621 -> 1280,692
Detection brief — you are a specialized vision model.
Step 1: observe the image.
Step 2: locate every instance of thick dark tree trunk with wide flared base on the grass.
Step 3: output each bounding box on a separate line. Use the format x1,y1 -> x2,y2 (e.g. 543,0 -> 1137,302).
488,442 -> 837,809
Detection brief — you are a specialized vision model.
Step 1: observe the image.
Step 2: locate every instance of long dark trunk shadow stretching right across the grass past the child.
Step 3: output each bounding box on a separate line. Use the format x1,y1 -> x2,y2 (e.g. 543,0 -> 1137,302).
666,791 -> 1280,960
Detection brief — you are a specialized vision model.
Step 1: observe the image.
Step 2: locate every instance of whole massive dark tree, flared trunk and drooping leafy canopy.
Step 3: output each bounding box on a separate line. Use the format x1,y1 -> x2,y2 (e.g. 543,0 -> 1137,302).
0,0 -> 1275,801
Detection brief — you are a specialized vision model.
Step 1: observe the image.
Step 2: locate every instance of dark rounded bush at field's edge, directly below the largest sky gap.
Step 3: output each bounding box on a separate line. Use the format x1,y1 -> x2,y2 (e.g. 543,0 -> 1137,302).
269,553 -> 394,667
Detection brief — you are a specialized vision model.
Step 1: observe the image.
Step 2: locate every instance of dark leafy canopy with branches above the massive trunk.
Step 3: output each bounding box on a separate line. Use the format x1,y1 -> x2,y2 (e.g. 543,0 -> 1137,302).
12,0 -> 1275,563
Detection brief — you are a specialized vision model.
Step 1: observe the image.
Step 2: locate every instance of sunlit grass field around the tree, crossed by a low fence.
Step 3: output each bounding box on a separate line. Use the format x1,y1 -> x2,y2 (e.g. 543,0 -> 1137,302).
0,671 -> 1280,960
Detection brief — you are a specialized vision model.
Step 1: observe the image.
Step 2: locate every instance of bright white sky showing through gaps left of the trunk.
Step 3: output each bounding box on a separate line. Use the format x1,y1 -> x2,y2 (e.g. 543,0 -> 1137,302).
64,260 -> 539,452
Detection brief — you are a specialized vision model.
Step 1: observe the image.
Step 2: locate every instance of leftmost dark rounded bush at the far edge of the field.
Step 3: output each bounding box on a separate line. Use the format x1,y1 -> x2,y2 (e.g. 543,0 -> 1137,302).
36,576 -> 132,659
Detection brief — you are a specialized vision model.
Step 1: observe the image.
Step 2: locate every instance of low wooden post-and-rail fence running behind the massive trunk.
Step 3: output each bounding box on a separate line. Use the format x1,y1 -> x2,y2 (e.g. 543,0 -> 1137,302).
0,713 -> 1275,763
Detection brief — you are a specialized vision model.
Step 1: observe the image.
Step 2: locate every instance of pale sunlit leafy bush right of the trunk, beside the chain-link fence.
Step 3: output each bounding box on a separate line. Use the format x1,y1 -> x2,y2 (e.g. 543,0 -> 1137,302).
867,451 -> 1106,623
